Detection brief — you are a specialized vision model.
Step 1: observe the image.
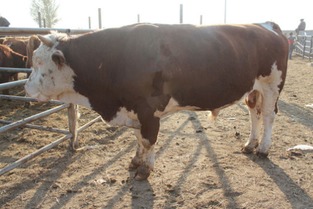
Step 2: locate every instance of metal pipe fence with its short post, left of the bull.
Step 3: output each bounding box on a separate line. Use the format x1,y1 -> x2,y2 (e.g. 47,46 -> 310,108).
0,27 -> 101,175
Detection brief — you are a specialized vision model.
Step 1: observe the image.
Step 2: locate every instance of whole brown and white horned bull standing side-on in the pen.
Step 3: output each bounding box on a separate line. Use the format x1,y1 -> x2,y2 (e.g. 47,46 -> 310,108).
25,22 -> 288,179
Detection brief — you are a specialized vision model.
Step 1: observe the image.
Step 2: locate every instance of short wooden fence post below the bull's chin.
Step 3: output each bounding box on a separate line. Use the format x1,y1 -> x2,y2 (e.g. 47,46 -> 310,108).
68,104 -> 78,150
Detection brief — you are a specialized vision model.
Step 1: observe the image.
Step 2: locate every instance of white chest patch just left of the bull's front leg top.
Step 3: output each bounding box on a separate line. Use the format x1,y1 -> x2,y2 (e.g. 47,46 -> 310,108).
108,107 -> 140,128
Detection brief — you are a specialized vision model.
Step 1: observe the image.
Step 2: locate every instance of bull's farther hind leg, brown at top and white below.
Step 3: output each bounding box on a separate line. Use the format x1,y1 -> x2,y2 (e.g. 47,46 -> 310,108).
242,90 -> 262,154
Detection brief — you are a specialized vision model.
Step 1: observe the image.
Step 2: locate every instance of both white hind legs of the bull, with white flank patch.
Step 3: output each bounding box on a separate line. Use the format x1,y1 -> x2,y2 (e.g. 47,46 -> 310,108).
245,62 -> 282,154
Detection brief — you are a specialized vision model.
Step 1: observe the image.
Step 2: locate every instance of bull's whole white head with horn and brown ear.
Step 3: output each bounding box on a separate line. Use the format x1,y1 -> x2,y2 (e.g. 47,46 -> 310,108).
25,34 -> 75,101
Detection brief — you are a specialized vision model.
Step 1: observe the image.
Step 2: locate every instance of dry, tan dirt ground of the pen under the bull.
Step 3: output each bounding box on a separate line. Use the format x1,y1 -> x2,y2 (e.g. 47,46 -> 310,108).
0,58 -> 313,209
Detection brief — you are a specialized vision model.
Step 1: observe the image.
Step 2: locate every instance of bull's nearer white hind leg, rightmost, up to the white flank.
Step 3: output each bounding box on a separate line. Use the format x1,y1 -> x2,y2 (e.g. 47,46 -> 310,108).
257,62 -> 282,155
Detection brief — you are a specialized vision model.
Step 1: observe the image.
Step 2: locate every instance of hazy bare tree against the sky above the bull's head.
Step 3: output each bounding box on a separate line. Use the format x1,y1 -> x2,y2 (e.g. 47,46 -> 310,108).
30,0 -> 60,28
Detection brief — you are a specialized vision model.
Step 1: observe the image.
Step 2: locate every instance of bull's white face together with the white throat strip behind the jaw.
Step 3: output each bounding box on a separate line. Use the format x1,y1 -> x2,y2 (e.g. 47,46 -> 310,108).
25,34 -> 90,107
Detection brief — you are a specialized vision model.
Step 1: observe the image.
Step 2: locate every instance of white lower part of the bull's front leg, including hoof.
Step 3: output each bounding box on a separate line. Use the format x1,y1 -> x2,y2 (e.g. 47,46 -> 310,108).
130,129 -> 155,180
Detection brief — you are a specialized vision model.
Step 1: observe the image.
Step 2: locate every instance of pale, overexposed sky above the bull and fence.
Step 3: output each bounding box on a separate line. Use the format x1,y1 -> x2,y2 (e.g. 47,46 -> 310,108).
0,0 -> 313,30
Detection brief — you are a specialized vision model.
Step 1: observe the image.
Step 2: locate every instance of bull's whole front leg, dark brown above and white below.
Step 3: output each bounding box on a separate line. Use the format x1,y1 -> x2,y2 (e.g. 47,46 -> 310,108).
129,110 -> 160,180
